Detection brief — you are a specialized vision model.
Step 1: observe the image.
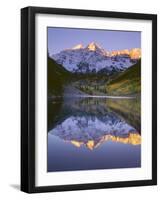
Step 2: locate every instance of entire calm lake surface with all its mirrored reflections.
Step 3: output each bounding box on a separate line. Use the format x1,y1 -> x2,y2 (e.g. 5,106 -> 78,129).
47,97 -> 141,172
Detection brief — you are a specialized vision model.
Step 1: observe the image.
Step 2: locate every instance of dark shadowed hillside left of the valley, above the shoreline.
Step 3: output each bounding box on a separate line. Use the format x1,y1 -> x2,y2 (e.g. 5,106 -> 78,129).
47,57 -> 71,96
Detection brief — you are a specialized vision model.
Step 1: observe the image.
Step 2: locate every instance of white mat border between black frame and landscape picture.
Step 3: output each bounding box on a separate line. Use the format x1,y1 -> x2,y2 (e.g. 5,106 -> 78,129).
35,14 -> 152,186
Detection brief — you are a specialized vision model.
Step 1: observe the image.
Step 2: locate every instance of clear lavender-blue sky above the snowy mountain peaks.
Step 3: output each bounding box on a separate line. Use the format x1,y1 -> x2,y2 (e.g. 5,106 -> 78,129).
48,27 -> 141,55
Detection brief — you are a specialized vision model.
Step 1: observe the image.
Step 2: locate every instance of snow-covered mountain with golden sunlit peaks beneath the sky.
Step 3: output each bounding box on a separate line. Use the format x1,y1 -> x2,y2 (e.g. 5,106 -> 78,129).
51,42 -> 141,74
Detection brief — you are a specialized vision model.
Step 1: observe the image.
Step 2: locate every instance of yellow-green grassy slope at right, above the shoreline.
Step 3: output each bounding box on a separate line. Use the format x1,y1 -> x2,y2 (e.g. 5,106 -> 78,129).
107,60 -> 141,95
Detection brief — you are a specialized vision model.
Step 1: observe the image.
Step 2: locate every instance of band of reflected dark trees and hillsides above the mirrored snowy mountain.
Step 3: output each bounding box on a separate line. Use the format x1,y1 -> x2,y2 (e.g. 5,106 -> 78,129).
48,98 -> 141,132
